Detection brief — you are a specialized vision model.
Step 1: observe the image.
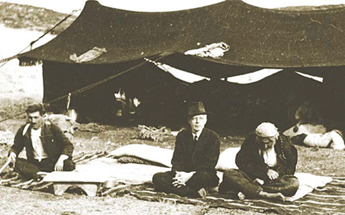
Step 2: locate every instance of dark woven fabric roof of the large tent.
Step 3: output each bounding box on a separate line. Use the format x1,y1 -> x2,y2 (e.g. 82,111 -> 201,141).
19,0 -> 345,70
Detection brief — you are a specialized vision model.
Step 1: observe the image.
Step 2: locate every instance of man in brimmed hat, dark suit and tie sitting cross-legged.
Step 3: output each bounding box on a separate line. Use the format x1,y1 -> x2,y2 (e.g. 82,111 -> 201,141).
152,102 -> 220,198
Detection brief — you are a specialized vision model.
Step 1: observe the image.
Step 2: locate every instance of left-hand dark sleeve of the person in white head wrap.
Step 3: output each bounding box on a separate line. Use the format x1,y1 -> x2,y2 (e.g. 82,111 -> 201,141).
236,134 -> 269,180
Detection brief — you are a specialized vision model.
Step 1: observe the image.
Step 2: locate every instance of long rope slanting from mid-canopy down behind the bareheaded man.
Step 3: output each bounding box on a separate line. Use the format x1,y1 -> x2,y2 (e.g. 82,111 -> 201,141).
0,52 -> 172,123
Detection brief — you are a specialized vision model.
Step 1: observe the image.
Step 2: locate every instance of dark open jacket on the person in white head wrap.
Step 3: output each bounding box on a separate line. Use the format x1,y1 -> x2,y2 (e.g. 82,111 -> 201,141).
236,133 -> 297,181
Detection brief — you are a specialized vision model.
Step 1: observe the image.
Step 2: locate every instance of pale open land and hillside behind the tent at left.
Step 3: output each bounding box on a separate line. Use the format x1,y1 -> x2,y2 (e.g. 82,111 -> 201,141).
0,2 -> 76,120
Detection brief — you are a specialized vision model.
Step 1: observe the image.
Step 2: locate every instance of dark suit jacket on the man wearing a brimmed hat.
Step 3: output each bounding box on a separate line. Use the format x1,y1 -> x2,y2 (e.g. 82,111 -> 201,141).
171,128 -> 220,173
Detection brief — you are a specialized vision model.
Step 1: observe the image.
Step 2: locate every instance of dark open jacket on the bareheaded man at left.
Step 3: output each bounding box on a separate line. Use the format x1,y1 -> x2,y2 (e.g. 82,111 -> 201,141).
10,123 -> 73,162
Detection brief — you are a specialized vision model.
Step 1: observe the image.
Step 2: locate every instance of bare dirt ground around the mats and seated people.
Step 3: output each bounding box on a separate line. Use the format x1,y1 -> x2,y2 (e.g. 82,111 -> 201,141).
0,119 -> 345,215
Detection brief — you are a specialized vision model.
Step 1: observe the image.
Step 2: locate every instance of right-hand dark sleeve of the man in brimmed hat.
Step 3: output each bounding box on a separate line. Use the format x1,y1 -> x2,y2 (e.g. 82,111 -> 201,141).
196,133 -> 220,171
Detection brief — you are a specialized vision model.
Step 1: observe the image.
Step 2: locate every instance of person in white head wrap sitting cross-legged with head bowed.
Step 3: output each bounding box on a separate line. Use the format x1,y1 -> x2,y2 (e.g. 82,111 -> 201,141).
219,122 -> 299,201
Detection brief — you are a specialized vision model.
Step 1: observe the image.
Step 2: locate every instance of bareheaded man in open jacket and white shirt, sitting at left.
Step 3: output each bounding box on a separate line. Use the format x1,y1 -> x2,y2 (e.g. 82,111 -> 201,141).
8,104 -> 75,179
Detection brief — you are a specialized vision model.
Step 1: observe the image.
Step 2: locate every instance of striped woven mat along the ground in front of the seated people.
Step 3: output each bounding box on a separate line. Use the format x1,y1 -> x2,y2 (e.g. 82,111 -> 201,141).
100,177 -> 345,215
